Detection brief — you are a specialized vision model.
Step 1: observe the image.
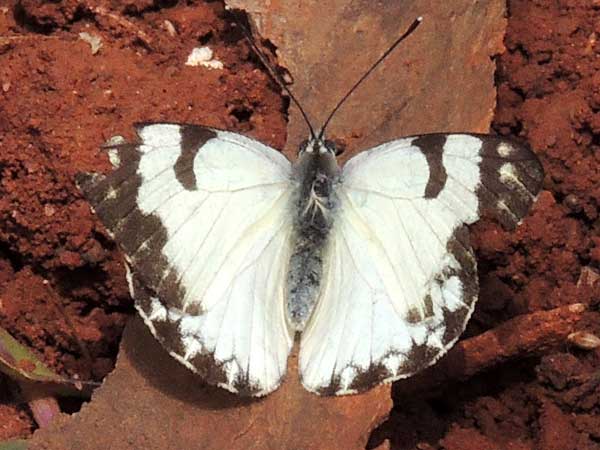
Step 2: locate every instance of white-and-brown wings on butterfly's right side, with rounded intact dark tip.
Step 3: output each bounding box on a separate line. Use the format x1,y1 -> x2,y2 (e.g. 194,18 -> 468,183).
300,134 -> 543,394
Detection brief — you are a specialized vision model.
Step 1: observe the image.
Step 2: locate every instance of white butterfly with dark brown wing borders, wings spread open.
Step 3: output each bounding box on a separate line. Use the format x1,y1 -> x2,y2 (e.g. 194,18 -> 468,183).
77,18 -> 544,396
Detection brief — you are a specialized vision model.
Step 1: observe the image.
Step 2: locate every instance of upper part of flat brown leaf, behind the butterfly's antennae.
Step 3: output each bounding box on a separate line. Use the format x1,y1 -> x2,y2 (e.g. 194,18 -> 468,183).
226,0 -> 506,158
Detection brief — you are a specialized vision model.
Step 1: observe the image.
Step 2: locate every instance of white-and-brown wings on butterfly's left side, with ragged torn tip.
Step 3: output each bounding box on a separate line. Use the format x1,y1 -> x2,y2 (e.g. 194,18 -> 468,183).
78,124 -> 293,395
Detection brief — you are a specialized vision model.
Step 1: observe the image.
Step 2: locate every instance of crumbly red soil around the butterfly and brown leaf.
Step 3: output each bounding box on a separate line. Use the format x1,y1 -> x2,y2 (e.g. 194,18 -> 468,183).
0,0 -> 600,450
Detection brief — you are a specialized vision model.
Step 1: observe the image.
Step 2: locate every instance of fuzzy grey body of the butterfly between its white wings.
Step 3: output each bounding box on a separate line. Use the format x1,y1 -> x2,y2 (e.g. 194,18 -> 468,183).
287,140 -> 339,331
